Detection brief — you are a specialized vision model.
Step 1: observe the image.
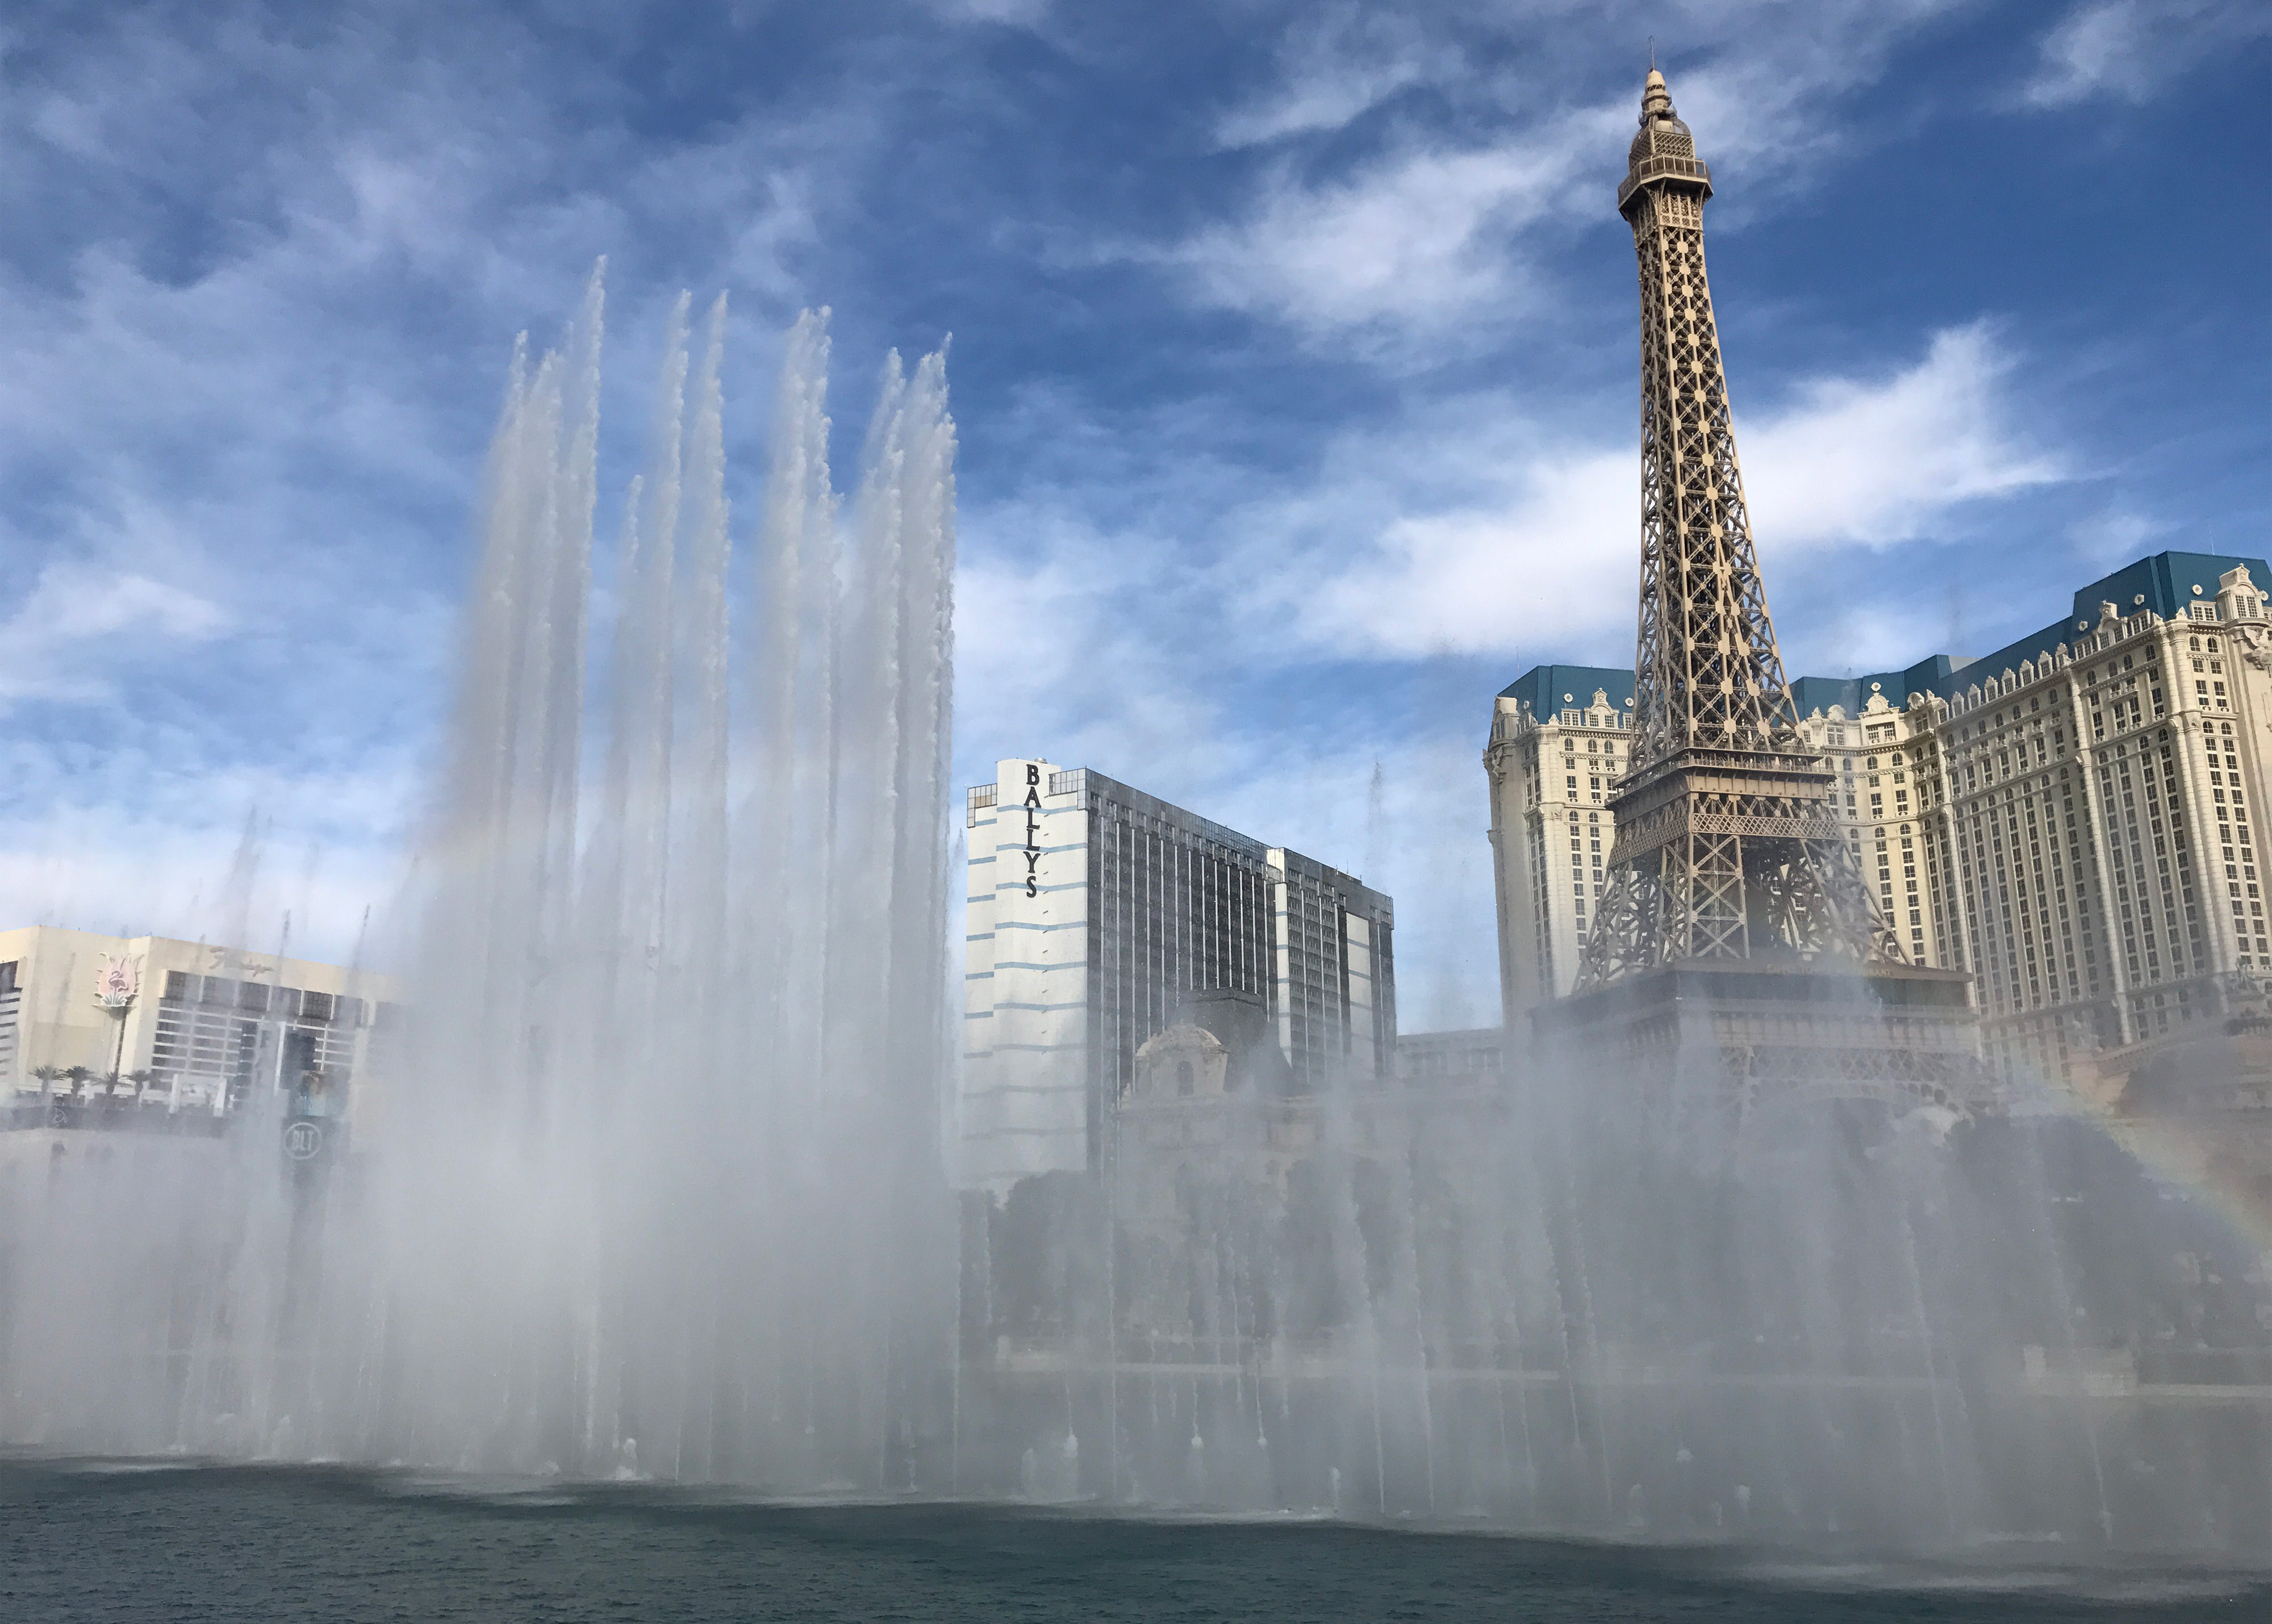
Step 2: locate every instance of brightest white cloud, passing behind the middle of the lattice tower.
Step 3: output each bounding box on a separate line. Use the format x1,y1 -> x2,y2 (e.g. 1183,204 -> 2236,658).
1263,327 -> 2061,659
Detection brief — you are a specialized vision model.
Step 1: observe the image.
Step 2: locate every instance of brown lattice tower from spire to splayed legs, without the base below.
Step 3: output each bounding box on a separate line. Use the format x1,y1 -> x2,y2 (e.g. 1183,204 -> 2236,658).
1577,68 -> 1904,993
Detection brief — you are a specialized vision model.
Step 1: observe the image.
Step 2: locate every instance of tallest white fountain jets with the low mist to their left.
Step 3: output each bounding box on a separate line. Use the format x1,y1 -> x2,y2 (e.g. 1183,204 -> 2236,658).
0,270 -> 954,1488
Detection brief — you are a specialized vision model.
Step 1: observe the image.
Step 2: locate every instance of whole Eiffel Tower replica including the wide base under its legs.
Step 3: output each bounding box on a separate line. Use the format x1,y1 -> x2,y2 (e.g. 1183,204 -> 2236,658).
1536,68 -> 1986,1133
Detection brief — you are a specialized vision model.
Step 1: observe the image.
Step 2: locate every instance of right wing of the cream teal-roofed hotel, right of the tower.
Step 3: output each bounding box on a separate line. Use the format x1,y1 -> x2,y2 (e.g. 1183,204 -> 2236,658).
1902,566 -> 2272,1081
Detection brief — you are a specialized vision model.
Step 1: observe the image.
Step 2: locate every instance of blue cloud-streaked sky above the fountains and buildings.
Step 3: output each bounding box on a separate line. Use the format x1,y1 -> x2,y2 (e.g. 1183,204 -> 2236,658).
0,0 -> 2272,1027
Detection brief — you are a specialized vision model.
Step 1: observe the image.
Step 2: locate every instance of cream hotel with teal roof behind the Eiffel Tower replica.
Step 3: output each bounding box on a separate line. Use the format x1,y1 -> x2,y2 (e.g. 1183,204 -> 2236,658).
1484,552 -> 2272,1095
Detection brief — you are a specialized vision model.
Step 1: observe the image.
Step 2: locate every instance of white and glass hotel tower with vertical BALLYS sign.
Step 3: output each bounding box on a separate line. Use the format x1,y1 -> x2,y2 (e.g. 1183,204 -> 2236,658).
961,759 -> 1395,1190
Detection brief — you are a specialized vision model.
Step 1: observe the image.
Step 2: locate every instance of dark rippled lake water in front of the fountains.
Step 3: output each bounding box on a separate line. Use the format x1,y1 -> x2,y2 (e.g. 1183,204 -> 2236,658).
0,1460 -> 2272,1624
